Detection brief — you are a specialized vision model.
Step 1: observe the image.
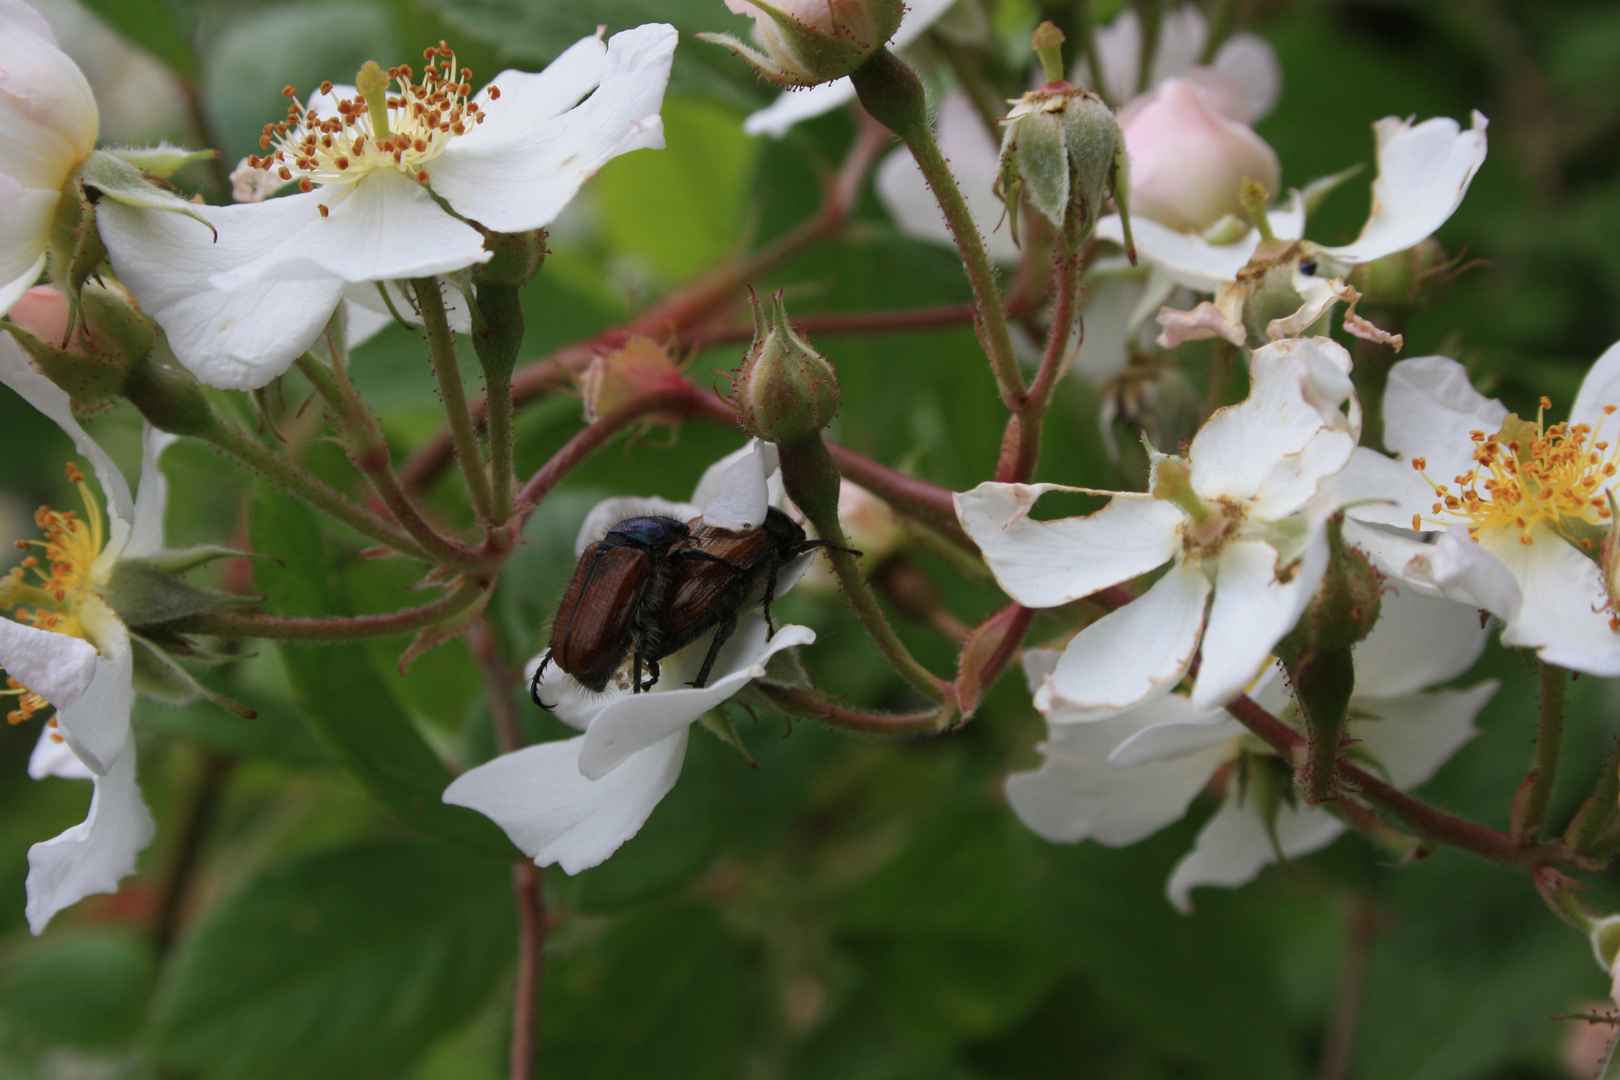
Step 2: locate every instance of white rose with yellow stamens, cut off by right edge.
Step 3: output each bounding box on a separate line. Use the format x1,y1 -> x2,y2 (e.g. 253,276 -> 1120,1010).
1335,345 -> 1620,677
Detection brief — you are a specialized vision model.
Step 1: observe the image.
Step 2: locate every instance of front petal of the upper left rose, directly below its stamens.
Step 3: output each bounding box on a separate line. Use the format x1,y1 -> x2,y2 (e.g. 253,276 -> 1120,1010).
209,168 -> 491,291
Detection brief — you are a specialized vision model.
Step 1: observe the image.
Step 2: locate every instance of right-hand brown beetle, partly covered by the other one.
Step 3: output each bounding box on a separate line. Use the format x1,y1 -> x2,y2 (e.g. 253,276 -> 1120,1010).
656,507 -> 860,687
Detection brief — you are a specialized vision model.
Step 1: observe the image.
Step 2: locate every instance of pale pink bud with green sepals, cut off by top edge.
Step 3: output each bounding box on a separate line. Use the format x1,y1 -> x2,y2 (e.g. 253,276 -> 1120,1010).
698,0 -> 906,86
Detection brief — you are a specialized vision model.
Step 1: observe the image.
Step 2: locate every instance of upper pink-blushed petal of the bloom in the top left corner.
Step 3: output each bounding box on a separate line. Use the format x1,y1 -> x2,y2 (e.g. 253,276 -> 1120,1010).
0,0 -> 99,191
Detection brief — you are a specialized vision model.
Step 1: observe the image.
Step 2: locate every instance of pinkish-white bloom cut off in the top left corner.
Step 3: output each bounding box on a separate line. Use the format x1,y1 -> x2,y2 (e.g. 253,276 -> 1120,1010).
0,0 -> 100,314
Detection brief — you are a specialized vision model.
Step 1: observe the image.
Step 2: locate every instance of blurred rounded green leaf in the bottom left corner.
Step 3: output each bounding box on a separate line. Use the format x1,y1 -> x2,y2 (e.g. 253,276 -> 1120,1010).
0,931 -> 152,1049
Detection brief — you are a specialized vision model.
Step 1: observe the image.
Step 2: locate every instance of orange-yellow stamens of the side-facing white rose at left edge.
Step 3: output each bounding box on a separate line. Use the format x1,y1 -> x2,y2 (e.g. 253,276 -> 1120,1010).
0,463 -> 107,724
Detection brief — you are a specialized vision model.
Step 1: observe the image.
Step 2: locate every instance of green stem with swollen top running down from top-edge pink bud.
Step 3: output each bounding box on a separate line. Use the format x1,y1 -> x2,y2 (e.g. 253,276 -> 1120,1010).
851,49 -> 1024,411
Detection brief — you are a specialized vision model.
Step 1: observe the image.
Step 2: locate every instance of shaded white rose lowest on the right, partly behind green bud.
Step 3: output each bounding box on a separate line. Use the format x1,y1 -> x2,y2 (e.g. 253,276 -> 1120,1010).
1006,589 -> 1499,912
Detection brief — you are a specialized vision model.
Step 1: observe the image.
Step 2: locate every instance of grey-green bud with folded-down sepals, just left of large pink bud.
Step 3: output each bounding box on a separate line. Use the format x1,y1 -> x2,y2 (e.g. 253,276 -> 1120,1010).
996,83 -> 1129,244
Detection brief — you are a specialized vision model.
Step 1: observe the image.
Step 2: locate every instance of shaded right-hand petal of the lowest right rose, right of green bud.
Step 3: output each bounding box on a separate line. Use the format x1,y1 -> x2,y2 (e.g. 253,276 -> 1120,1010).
1356,581 -> 1489,698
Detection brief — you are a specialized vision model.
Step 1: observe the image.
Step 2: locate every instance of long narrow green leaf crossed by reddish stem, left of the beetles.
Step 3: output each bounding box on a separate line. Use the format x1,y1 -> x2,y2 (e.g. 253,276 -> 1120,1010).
253,484 -> 518,860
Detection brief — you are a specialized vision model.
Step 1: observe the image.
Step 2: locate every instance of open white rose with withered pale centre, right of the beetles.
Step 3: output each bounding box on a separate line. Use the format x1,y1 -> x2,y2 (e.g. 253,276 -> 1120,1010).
956,338 -> 1361,716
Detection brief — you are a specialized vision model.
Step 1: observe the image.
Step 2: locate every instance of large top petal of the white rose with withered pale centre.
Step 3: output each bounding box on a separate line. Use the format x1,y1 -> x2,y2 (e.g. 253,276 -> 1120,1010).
1187,338 -> 1359,521
